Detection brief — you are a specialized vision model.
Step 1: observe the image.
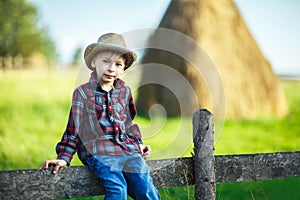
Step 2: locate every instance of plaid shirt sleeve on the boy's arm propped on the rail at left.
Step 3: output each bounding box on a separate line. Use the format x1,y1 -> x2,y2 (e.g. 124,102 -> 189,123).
56,90 -> 84,165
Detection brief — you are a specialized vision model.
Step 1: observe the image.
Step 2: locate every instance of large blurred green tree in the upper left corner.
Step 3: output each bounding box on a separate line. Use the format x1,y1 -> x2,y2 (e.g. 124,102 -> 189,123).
0,0 -> 56,69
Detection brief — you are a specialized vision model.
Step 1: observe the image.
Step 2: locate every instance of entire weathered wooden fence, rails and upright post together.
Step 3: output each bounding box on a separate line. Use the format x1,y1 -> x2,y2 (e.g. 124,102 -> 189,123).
0,110 -> 300,200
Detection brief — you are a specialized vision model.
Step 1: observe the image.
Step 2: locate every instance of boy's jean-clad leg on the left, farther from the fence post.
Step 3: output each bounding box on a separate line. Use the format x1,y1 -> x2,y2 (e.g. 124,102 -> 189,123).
87,156 -> 127,200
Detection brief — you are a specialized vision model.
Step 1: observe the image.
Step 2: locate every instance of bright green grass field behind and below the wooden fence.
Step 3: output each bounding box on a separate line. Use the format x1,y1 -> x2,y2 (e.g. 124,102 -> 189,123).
0,69 -> 300,199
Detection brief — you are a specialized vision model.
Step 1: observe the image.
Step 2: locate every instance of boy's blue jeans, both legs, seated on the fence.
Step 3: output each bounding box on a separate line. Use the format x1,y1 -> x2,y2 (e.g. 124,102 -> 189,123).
86,152 -> 160,200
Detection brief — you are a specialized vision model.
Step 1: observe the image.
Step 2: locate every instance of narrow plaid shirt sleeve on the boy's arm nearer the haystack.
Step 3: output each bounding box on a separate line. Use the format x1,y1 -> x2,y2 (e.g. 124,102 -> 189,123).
125,90 -> 143,144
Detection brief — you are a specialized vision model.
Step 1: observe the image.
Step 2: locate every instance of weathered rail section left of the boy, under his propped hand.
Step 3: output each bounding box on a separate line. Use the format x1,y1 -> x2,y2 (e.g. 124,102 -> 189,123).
0,167 -> 103,200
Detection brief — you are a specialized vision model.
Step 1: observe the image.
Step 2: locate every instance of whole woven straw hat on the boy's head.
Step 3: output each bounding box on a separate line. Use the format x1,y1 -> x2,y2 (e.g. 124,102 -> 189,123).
84,33 -> 137,70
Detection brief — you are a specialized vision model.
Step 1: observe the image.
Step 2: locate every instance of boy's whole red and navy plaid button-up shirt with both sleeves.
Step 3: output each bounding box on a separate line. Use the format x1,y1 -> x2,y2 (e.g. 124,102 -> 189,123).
56,72 -> 142,164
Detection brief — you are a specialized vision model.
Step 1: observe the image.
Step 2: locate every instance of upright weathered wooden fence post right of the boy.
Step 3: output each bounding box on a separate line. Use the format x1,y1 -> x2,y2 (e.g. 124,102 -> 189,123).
193,109 -> 216,200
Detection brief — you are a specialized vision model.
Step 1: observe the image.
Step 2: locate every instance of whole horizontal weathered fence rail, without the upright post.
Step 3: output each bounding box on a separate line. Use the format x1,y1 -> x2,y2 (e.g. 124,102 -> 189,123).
0,151 -> 300,200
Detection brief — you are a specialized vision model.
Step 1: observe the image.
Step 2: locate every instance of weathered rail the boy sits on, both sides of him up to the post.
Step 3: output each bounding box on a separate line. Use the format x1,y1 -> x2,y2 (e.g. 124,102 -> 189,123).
0,158 -> 194,200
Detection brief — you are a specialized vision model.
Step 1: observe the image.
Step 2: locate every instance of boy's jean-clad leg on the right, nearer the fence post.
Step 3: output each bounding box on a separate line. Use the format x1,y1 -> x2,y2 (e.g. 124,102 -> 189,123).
123,154 -> 160,200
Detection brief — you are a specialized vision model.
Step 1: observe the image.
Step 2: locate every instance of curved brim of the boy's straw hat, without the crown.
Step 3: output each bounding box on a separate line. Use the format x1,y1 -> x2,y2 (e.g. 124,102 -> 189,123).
84,43 -> 137,70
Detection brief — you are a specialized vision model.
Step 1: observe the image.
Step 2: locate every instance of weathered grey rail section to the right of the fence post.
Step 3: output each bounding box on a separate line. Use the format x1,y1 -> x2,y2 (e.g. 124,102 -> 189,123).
215,151 -> 300,183
